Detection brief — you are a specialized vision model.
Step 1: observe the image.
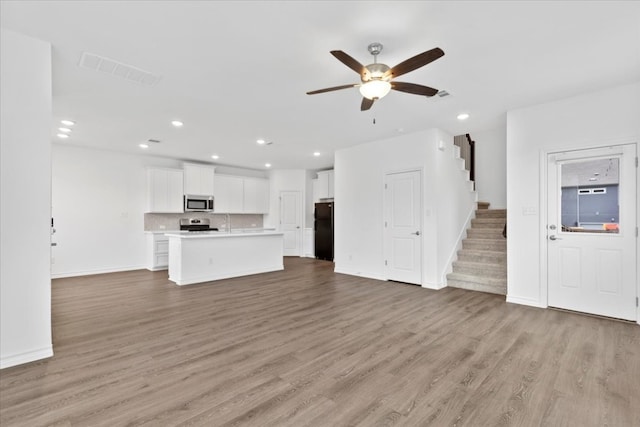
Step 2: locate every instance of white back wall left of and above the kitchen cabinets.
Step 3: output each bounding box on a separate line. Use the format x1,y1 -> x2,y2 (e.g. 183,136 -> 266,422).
51,143 -> 265,277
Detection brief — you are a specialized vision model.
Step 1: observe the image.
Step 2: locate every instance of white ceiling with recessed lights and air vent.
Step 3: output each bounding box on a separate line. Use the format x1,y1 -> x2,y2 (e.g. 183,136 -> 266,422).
0,0 -> 640,169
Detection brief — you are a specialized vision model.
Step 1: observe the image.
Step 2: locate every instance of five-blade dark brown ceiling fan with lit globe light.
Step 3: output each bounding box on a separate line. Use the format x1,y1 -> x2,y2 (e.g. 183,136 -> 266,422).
307,43 -> 444,111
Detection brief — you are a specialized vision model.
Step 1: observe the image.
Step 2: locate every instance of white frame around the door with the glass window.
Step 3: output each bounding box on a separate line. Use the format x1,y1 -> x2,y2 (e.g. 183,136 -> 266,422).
538,138 -> 640,325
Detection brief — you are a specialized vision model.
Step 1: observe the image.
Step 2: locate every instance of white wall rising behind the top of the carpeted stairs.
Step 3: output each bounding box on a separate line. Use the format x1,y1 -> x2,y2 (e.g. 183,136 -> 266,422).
471,126 -> 507,209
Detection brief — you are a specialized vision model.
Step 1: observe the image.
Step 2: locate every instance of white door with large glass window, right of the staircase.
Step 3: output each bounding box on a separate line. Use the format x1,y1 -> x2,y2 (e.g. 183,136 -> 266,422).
547,145 -> 638,320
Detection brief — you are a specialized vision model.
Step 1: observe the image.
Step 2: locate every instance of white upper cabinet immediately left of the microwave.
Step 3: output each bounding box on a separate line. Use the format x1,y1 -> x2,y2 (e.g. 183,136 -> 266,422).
147,168 -> 183,213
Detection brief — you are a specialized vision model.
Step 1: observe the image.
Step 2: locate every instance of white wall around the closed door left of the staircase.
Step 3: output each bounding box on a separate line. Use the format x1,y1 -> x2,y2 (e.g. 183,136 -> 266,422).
334,129 -> 475,288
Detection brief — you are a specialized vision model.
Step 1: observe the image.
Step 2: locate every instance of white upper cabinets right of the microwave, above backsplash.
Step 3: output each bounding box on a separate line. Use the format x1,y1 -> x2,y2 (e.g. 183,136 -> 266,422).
214,174 -> 269,214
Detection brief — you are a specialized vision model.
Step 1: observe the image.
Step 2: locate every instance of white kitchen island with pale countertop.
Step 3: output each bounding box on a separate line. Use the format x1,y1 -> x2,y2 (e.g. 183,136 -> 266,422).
165,230 -> 284,285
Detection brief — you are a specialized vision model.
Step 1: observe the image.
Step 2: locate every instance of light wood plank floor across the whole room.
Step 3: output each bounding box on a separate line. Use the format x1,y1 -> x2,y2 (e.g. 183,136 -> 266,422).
0,258 -> 640,427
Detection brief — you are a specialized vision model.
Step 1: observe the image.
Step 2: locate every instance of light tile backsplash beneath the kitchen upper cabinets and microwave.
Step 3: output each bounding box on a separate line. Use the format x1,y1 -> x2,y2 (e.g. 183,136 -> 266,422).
144,212 -> 263,231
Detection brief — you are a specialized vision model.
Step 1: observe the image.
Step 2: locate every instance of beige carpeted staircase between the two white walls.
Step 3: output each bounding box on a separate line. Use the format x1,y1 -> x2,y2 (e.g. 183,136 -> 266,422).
447,202 -> 507,295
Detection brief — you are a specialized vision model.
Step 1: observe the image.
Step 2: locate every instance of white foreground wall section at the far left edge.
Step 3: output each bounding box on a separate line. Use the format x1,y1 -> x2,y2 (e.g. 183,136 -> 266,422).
0,30 -> 53,368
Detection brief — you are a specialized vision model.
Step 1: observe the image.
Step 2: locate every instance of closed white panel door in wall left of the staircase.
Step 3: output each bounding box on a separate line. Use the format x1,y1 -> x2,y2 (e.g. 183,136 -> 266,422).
384,171 -> 422,285
